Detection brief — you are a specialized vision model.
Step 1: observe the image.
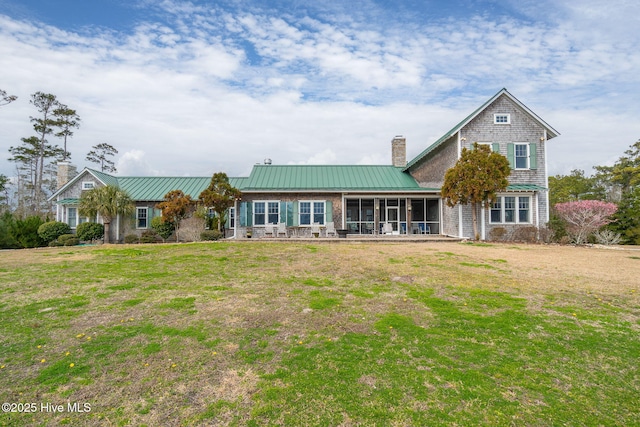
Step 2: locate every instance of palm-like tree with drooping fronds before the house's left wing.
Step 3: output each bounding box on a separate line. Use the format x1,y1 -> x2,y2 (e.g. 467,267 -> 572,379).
78,185 -> 135,243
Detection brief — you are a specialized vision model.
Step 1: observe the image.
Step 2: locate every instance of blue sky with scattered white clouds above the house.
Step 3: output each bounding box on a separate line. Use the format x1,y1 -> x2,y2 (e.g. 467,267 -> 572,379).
0,0 -> 640,176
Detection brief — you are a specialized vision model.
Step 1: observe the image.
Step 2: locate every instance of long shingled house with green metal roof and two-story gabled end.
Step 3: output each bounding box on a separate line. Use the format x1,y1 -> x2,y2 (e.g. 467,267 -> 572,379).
51,89 -> 559,240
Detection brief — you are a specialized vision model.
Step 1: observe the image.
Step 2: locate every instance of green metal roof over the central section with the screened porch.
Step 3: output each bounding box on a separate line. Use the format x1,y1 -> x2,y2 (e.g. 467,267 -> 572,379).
240,165 -> 429,192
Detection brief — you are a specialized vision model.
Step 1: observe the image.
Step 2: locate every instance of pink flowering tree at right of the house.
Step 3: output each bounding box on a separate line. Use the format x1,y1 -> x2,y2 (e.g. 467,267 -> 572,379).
555,200 -> 618,244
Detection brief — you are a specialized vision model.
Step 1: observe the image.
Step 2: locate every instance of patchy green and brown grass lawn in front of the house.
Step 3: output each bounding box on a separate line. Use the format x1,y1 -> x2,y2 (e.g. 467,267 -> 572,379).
0,242 -> 640,426
